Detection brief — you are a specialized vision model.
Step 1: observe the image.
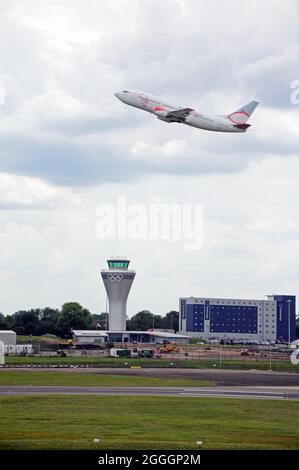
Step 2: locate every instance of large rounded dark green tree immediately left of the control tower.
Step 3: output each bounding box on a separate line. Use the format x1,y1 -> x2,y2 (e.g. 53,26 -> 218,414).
57,302 -> 92,337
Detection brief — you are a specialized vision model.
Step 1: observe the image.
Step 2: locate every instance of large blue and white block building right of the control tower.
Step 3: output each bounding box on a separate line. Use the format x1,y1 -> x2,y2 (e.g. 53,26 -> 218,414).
179,295 -> 296,342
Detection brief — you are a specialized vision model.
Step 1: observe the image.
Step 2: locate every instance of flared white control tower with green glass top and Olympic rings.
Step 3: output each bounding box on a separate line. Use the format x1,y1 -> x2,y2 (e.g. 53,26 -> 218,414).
101,257 -> 136,331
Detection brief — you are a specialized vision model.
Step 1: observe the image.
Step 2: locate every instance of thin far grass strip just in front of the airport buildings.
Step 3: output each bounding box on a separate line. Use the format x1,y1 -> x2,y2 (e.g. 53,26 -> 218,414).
5,356 -> 299,373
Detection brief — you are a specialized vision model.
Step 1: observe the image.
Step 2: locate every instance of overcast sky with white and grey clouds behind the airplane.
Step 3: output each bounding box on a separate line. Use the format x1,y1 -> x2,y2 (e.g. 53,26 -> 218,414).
0,0 -> 299,315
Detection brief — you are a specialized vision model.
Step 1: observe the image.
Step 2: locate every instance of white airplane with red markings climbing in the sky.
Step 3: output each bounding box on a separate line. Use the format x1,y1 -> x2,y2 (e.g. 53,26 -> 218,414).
114,90 -> 259,132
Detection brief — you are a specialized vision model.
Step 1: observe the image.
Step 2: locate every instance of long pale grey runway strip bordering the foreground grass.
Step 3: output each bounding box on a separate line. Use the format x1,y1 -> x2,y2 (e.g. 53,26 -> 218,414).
0,386 -> 299,400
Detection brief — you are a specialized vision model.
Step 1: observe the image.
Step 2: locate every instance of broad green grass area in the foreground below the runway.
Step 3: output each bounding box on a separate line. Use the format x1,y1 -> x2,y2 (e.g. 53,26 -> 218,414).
0,395 -> 299,450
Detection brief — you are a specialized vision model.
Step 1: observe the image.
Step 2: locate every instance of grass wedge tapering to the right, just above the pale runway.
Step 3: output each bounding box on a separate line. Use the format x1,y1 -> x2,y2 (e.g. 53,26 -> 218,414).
0,370 -> 215,387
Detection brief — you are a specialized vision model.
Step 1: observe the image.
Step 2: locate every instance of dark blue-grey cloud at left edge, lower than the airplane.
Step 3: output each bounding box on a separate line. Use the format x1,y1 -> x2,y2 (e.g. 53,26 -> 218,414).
0,136 -> 146,186
